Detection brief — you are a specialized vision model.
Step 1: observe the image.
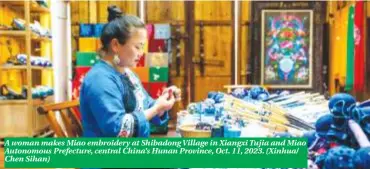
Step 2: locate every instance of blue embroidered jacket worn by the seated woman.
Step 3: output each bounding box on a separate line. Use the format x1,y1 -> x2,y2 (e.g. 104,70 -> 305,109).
80,61 -> 169,137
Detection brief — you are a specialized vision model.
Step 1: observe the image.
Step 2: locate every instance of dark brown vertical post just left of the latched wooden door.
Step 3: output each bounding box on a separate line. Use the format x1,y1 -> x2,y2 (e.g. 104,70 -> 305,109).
184,1 -> 195,105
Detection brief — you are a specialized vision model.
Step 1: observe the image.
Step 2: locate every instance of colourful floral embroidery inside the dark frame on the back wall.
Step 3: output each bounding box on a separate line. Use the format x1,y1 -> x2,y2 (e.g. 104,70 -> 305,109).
260,9 -> 314,88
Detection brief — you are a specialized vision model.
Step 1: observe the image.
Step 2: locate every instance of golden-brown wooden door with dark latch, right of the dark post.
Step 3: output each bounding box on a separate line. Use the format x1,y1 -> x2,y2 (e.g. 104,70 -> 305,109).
194,1 -> 233,101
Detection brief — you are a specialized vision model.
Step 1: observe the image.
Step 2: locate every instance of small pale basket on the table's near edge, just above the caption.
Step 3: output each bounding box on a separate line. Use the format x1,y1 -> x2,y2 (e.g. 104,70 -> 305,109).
180,124 -> 212,138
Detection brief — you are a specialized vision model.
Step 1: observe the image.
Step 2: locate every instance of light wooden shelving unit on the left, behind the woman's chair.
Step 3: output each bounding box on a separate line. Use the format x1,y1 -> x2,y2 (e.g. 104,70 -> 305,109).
0,0 -> 54,140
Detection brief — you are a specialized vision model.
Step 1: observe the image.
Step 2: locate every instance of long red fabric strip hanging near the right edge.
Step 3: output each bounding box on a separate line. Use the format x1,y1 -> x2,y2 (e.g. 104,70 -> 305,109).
354,1 -> 365,91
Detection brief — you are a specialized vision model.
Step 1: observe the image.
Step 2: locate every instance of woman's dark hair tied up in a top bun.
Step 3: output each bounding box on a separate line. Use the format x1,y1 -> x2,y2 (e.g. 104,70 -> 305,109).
100,5 -> 145,51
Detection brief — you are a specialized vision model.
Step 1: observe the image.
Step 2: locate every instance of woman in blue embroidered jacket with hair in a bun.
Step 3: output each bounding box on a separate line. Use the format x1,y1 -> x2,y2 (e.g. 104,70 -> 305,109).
80,6 -> 181,137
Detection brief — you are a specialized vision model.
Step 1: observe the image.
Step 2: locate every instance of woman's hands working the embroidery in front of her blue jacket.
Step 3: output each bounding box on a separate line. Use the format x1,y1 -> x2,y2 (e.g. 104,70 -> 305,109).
154,92 -> 176,116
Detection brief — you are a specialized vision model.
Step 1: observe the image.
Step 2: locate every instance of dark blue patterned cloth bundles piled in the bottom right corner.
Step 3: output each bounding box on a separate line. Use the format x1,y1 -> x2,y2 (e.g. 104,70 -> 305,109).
304,93 -> 370,169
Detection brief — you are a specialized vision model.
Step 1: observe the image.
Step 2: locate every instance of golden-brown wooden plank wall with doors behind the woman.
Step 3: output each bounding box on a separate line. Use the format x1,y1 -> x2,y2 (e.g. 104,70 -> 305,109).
71,1 -> 370,109
